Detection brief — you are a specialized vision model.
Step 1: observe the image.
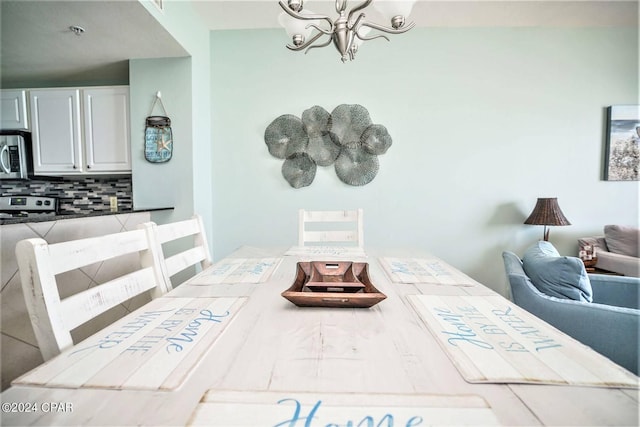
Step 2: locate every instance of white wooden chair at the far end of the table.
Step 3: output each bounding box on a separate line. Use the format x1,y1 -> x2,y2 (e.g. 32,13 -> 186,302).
298,209 -> 364,248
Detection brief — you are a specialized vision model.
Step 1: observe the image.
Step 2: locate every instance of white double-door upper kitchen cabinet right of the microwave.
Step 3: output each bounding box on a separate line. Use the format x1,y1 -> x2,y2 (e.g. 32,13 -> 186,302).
29,86 -> 131,175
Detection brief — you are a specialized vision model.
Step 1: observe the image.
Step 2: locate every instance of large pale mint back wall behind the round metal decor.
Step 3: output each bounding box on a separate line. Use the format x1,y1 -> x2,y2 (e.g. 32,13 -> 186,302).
211,28 -> 639,294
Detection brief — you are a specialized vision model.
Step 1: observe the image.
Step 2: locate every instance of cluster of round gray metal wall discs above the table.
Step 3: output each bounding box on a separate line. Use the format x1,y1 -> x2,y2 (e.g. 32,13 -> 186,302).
264,104 -> 392,188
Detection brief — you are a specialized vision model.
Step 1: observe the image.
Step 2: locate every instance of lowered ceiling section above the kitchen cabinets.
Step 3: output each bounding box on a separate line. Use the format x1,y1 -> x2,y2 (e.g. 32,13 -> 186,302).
0,0 -> 188,87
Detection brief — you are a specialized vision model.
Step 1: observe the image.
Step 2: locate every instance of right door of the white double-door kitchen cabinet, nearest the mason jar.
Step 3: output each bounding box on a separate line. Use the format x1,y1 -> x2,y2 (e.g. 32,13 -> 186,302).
83,86 -> 131,173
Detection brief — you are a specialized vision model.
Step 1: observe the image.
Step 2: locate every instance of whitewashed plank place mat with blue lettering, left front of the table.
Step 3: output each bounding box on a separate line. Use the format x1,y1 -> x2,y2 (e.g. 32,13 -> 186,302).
14,298 -> 246,390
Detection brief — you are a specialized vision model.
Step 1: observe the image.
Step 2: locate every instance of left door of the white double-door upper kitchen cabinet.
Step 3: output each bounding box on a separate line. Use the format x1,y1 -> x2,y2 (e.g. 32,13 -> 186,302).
29,89 -> 84,175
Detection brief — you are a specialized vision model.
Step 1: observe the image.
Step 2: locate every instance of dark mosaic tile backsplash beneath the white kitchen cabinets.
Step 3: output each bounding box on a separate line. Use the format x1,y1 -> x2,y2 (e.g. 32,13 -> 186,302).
0,175 -> 133,214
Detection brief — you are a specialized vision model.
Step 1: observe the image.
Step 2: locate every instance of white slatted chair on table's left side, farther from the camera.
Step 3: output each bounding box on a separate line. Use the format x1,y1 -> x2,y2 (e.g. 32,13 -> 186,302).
141,215 -> 211,290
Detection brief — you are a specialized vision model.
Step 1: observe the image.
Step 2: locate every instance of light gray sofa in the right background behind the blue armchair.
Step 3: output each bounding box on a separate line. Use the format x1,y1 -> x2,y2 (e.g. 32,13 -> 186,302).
578,225 -> 640,277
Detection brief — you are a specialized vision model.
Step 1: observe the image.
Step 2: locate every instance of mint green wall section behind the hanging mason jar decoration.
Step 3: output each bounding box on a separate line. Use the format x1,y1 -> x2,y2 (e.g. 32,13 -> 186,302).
134,0 -> 216,254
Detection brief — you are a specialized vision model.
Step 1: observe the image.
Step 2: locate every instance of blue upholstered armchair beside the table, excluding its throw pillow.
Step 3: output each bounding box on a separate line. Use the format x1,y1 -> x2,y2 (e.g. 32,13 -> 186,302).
502,252 -> 640,375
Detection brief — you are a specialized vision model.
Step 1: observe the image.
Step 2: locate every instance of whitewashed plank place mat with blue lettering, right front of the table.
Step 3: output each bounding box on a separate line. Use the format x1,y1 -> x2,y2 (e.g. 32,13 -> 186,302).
408,295 -> 638,388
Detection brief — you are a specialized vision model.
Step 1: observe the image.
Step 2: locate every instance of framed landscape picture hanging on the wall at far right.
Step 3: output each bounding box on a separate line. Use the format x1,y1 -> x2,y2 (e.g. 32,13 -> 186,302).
604,105 -> 640,181
